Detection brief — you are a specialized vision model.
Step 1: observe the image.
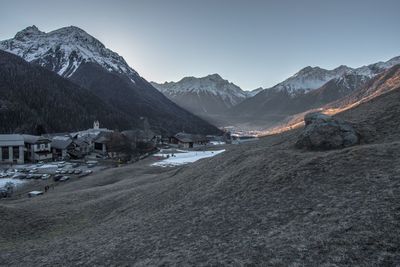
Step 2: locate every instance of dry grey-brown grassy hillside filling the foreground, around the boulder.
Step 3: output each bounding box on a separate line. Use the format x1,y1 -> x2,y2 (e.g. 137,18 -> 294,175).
0,78 -> 400,266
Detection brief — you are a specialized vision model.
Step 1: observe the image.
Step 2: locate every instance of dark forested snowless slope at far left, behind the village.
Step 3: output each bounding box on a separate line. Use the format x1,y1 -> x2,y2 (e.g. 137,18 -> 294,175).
0,51 -> 132,133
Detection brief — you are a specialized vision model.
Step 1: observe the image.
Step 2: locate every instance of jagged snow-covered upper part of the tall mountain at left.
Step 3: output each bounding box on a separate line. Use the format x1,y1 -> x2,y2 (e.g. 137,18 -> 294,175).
0,25 -> 140,82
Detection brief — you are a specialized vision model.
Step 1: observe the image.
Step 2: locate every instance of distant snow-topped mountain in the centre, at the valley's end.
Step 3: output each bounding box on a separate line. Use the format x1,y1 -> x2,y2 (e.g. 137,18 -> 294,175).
152,74 -> 247,117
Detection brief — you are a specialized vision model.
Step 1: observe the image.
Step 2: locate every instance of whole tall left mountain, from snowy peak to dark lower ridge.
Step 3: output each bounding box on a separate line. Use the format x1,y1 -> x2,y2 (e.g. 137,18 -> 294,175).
0,26 -> 220,134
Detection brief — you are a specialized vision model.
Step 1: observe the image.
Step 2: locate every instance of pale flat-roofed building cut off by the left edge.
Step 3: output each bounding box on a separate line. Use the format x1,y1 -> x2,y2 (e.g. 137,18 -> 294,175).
0,134 -> 24,164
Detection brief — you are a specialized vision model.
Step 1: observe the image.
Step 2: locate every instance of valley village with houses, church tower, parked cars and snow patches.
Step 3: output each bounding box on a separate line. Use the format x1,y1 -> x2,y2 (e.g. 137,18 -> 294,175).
0,121 -> 256,198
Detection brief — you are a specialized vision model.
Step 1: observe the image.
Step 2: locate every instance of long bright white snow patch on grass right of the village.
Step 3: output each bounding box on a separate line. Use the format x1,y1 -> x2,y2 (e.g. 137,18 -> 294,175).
151,149 -> 225,167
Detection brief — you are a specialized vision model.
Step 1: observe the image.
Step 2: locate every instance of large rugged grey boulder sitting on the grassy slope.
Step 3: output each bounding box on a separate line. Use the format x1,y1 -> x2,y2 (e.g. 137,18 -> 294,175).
296,113 -> 360,150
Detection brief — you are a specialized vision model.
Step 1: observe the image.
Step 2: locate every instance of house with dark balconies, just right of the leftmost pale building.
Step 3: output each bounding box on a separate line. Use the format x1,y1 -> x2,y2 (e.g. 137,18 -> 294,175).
22,134 -> 53,162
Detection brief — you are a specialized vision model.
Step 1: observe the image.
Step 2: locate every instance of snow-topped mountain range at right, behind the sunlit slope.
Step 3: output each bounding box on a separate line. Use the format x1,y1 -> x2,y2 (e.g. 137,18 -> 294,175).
226,57 -> 400,128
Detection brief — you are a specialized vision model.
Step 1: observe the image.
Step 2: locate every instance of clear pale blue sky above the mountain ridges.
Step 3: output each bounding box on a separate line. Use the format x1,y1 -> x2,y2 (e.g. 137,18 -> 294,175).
0,0 -> 400,90
